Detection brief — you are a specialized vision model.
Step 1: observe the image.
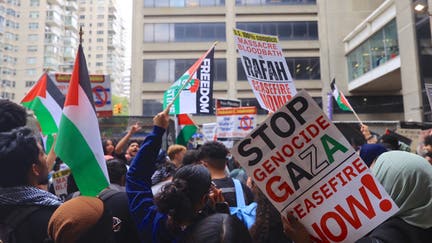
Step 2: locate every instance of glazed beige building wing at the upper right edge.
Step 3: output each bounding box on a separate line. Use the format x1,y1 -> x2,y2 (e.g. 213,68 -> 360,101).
340,0 -> 432,122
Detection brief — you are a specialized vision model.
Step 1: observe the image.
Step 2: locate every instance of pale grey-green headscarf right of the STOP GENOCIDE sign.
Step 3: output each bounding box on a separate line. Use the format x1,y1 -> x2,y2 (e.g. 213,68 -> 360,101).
372,151 -> 432,229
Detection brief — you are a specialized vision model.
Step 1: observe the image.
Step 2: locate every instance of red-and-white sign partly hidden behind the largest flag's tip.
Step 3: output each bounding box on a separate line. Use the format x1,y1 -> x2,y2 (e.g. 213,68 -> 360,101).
49,73 -> 112,117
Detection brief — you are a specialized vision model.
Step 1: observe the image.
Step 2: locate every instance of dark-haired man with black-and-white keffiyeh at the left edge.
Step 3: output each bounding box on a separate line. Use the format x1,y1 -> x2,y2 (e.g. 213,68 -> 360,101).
0,127 -> 61,243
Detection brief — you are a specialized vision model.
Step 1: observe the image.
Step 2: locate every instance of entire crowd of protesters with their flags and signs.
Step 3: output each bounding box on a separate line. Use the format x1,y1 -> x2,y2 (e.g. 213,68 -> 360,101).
0,28 -> 432,243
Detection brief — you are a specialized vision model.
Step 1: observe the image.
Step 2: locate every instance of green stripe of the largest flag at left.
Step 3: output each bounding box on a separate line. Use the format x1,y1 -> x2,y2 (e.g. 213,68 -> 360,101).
55,115 -> 109,196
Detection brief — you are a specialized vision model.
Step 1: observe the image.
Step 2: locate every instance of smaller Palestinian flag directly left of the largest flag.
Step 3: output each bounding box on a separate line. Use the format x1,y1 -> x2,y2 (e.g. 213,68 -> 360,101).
21,73 -> 65,135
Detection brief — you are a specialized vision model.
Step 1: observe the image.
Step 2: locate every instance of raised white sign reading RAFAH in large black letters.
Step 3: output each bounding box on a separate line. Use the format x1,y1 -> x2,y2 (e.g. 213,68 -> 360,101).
234,29 -> 297,112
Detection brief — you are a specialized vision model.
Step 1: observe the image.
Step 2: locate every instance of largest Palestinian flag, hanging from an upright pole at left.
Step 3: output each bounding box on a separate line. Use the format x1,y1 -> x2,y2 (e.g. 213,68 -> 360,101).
54,44 -> 109,196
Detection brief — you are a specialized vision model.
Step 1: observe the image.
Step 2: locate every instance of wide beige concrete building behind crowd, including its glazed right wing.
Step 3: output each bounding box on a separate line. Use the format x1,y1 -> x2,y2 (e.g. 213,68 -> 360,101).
131,0 -> 431,123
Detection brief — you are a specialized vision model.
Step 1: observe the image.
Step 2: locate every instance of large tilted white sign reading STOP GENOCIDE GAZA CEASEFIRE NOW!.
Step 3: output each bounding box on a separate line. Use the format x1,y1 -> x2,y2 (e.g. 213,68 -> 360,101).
231,91 -> 398,242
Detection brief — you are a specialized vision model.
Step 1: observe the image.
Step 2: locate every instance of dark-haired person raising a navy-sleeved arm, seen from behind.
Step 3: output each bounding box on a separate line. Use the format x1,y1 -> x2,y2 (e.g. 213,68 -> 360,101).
126,109 -> 236,242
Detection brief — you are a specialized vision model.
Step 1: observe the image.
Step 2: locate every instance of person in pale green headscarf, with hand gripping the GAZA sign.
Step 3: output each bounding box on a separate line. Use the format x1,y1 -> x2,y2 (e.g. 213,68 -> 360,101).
283,151 -> 432,243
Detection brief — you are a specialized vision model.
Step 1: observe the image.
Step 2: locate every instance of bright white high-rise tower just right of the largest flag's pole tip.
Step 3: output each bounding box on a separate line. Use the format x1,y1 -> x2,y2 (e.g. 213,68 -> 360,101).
78,0 -> 125,93
